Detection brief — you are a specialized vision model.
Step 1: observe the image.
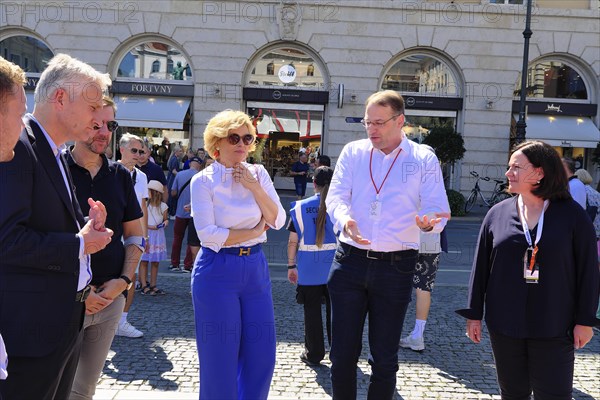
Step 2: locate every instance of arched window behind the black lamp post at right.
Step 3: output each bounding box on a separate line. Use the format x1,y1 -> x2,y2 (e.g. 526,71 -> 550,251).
514,59 -> 588,100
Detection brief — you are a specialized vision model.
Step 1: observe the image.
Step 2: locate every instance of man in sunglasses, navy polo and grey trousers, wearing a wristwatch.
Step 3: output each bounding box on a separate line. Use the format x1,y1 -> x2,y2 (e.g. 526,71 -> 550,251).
67,98 -> 143,399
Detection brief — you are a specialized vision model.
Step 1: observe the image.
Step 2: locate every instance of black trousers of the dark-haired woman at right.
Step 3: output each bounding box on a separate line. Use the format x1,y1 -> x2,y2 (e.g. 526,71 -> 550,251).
488,329 -> 575,400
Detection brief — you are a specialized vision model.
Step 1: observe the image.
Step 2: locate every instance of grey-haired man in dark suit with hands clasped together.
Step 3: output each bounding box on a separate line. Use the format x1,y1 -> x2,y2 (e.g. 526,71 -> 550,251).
0,54 -> 112,399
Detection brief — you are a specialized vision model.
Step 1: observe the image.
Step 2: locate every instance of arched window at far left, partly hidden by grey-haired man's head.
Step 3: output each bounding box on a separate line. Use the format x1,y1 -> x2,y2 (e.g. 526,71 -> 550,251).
0,36 -> 54,73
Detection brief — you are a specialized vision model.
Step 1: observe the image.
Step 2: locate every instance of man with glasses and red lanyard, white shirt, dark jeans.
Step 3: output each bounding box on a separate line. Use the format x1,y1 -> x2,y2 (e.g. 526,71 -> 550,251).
326,90 -> 450,400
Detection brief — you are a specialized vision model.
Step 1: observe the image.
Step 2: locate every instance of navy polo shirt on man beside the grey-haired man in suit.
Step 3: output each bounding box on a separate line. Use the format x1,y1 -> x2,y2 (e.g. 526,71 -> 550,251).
66,150 -> 143,285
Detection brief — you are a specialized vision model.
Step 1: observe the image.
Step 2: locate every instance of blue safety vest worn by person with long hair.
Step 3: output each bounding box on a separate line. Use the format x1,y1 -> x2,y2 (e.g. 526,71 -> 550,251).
290,194 -> 337,286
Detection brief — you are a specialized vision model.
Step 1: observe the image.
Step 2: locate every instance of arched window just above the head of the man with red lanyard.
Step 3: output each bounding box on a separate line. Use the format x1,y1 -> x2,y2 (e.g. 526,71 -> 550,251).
381,53 -> 459,96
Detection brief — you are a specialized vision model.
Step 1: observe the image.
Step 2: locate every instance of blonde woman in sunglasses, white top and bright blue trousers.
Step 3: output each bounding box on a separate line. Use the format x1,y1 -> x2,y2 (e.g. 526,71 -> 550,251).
191,110 -> 286,399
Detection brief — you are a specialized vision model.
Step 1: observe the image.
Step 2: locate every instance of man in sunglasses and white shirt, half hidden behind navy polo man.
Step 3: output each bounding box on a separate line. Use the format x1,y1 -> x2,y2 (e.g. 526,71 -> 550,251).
116,133 -> 148,338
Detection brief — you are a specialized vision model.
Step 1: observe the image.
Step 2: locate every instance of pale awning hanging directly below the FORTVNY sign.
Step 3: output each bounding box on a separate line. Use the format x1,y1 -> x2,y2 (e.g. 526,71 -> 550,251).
114,96 -> 190,130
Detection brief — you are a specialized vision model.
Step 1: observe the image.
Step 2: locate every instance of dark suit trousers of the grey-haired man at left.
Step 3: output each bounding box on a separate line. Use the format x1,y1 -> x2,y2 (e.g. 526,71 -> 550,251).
0,303 -> 85,400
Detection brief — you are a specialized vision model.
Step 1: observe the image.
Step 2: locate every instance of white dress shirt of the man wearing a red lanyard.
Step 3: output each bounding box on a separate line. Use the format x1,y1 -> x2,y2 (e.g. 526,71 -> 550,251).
326,137 -> 450,252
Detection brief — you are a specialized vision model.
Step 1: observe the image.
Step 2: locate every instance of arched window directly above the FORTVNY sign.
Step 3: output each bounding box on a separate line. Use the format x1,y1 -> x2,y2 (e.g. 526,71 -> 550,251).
117,41 -> 193,80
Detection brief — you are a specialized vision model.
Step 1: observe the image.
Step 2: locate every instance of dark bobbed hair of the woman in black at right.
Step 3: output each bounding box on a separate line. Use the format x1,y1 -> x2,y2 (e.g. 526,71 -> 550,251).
511,140 -> 571,200
